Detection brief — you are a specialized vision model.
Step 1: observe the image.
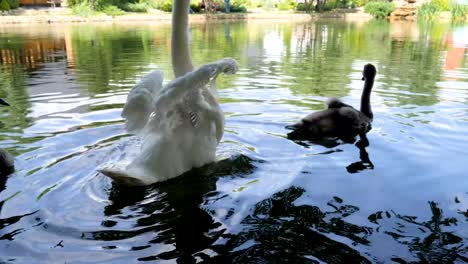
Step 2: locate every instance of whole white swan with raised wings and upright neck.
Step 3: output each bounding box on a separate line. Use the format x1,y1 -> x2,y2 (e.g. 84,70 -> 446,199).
101,0 -> 237,185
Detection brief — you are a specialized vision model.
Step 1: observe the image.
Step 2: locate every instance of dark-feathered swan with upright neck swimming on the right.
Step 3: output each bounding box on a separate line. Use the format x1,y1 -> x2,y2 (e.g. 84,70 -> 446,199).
286,64 -> 376,139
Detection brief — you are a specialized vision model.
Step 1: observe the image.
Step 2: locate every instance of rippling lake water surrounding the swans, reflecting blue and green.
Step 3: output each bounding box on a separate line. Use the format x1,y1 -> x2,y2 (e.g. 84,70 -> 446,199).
0,21 -> 468,263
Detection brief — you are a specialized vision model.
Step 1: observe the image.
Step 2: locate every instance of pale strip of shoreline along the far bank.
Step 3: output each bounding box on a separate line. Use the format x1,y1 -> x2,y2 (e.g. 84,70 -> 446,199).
0,8 -> 372,25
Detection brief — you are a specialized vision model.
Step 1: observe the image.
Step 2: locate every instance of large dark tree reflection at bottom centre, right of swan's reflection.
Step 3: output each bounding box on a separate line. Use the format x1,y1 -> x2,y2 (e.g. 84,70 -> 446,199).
215,187 -> 371,263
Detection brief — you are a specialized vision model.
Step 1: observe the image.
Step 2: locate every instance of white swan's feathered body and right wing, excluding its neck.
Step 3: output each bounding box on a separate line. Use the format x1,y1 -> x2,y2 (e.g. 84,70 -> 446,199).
100,58 -> 237,184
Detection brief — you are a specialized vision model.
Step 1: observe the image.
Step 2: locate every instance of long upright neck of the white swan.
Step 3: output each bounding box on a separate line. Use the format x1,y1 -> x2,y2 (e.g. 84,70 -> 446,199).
171,0 -> 193,77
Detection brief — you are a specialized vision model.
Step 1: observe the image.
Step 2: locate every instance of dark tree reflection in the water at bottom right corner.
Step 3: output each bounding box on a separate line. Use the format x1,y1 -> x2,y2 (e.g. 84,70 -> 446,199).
369,201 -> 468,263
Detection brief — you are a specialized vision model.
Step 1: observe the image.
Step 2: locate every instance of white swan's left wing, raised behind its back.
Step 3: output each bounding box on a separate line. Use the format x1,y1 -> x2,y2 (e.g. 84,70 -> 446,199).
122,70 -> 163,134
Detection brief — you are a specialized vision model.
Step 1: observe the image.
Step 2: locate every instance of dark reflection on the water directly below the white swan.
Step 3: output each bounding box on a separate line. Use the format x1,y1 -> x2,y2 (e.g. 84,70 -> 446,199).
82,155 -> 255,263
